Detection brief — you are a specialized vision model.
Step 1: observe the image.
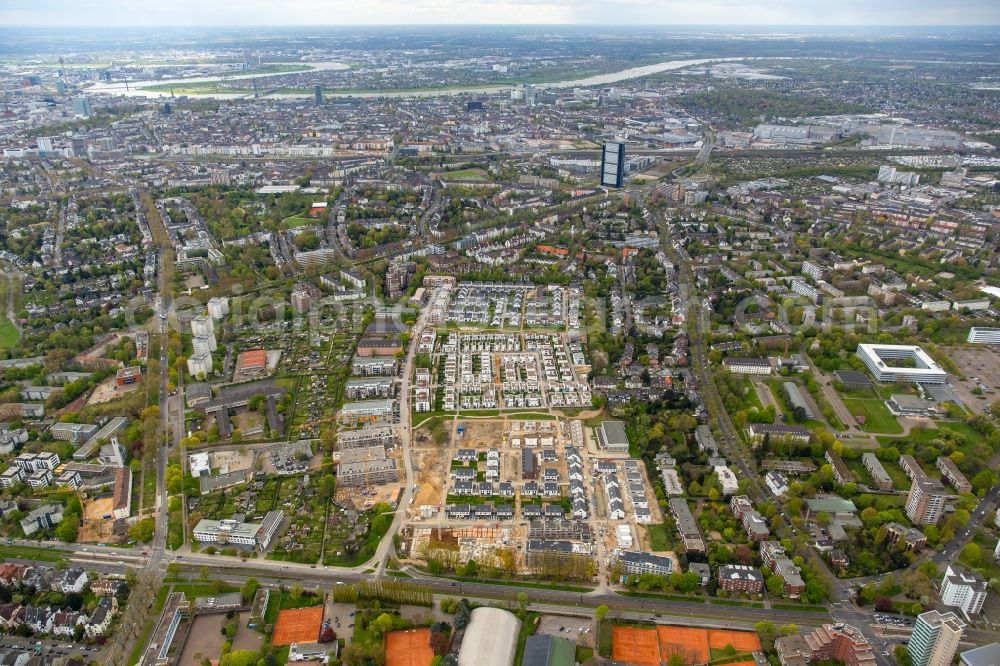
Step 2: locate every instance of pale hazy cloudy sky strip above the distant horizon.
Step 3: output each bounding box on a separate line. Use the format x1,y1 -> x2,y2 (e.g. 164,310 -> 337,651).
0,0 -> 1000,26
